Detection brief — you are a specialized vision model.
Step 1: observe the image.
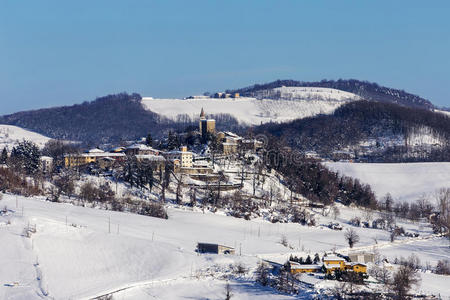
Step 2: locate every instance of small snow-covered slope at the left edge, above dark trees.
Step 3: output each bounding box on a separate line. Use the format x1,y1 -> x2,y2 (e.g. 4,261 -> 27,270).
0,125 -> 50,150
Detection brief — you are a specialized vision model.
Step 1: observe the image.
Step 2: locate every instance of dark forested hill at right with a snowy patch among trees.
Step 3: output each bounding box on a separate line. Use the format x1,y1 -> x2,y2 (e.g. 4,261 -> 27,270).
255,101 -> 450,161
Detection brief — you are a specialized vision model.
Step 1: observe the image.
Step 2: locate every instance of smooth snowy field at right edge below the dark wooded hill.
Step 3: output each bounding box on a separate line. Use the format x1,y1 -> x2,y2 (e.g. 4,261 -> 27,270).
325,162 -> 450,202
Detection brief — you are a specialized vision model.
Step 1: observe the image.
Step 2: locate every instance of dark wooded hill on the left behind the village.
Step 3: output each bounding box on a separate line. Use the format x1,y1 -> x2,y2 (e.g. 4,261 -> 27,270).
0,93 -> 170,144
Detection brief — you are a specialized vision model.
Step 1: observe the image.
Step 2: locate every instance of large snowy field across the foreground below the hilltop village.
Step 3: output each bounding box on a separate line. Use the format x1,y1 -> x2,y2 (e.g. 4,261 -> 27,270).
0,195 -> 450,299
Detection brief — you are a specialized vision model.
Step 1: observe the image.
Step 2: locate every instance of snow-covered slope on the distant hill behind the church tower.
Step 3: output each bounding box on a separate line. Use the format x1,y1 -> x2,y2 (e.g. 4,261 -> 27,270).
142,87 -> 360,125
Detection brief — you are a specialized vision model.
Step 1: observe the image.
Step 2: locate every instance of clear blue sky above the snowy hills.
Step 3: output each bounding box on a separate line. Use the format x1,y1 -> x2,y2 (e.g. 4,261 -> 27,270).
0,0 -> 450,114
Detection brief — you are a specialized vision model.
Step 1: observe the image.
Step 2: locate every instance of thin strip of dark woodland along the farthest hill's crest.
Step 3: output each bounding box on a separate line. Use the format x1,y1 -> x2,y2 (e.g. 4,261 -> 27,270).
227,79 -> 434,109
